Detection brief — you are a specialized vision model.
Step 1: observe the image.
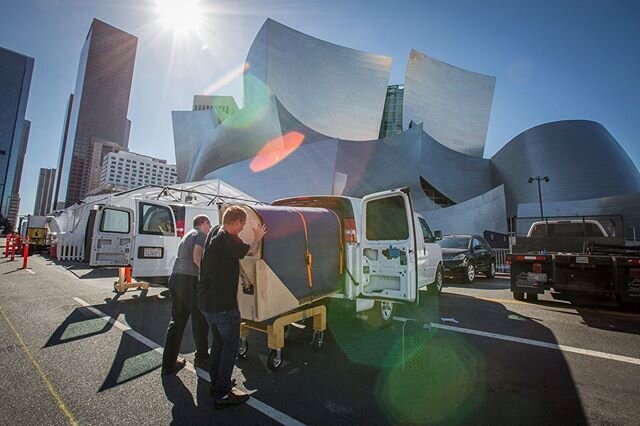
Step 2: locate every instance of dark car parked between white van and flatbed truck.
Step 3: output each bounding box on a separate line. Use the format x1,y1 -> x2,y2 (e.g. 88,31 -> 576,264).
438,235 -> 496,283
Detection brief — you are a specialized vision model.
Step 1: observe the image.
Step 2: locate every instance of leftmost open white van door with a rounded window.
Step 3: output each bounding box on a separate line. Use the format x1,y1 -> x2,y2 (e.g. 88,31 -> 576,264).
89,206 -> 133,266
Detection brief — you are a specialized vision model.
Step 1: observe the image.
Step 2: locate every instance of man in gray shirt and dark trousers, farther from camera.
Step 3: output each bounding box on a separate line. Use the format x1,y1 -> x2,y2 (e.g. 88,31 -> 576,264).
162,215 -> 211,375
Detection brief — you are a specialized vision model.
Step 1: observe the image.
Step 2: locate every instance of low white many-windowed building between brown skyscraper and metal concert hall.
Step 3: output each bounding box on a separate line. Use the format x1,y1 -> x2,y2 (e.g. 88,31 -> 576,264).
100,151 -> 178,189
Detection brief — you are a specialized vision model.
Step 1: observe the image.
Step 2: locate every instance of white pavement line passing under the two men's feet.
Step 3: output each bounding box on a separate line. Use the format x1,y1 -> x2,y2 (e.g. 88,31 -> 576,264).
73,297 -> 304,426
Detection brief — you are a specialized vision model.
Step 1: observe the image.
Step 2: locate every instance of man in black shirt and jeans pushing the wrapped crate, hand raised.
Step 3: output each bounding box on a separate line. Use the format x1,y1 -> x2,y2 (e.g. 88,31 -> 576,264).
198,206 -> 267,408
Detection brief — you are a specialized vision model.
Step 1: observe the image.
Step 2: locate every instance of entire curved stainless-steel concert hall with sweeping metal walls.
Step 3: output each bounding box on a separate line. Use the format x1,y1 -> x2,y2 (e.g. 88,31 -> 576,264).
174,20 -> 640,234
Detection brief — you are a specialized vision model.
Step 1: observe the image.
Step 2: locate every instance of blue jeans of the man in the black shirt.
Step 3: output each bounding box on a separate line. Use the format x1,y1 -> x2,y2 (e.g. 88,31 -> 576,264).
202,309 -> 240,399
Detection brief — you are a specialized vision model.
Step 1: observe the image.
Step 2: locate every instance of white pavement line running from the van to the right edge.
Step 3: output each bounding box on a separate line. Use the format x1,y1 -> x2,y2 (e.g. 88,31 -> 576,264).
394,317 -> 640,365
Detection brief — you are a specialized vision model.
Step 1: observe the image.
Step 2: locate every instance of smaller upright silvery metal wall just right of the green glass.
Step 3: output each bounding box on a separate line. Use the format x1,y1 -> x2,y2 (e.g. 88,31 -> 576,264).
402,49 -> 496,157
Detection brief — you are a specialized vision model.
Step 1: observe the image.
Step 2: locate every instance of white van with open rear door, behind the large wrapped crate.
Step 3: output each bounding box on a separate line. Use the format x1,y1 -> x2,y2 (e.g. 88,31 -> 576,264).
271,188 -> 443,324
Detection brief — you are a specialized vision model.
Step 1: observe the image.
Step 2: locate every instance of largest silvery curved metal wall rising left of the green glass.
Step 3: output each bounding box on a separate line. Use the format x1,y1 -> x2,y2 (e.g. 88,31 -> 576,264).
244,19 -> 391,140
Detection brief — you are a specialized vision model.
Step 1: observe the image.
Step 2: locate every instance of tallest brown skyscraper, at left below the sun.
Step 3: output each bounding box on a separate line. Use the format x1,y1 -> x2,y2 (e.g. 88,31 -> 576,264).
56,19 -> 138,207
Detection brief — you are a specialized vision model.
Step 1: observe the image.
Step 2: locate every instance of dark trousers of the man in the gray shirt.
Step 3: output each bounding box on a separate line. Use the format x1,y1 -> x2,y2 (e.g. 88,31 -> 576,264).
162,274 -> 209,368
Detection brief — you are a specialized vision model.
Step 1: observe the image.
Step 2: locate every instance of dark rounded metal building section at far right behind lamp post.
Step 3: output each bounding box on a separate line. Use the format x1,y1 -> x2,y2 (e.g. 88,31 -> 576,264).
491,120 -> 640,216
